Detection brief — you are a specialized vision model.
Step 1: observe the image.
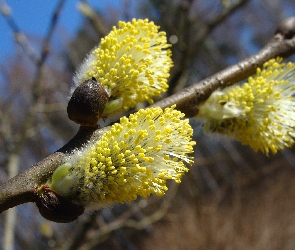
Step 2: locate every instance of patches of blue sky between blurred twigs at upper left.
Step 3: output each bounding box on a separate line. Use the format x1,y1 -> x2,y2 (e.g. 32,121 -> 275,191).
0,0 -> 128,62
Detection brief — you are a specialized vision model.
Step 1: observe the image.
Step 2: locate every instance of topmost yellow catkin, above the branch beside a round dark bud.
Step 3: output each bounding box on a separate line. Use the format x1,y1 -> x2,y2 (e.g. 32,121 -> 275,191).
74,19 -> 173,114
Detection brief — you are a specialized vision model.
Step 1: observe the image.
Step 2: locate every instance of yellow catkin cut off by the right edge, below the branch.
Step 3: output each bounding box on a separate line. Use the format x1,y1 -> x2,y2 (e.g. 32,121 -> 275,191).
197,58 -> 295,155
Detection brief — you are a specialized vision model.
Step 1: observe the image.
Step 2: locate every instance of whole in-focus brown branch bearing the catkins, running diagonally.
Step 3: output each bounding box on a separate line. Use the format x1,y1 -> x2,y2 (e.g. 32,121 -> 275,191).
0,17 -> 295,217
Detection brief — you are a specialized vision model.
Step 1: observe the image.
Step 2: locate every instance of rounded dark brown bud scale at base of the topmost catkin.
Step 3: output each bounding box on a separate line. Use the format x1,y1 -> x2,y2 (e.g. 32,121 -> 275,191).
67,78 -> 109,127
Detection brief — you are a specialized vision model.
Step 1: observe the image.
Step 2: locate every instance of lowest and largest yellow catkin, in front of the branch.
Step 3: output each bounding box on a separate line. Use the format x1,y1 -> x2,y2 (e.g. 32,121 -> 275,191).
51,106 -> 195,205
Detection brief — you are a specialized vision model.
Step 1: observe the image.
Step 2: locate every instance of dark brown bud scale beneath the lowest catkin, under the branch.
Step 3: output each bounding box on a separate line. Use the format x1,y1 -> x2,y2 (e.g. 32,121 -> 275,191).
36,185 -> 84,223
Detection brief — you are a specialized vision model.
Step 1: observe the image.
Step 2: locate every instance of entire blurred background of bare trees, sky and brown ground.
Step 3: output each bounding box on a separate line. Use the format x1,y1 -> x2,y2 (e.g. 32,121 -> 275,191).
0,0 -> 295,250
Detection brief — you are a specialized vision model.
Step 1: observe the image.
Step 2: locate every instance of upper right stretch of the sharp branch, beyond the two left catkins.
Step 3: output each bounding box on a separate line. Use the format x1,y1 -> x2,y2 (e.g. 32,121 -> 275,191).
153,20 -> 295,117
